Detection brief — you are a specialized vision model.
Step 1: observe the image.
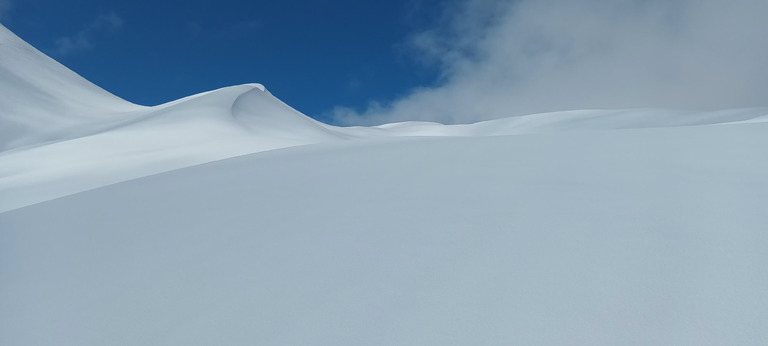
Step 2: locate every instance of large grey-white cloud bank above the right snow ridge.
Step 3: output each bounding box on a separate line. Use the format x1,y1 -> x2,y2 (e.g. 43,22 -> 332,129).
333,0 -> 768,125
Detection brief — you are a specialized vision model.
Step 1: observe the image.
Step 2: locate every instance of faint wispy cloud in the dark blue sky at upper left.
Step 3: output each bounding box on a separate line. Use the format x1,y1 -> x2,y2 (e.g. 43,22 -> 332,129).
54,12 -> 124,56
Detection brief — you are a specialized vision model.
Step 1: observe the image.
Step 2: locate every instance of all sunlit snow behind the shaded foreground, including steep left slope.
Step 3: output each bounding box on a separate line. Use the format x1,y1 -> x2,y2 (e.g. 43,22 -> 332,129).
0,25 -> 768,212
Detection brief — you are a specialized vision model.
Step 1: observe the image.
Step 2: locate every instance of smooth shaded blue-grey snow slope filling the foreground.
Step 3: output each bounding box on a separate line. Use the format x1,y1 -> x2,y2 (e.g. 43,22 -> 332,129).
0,124 -> 768,345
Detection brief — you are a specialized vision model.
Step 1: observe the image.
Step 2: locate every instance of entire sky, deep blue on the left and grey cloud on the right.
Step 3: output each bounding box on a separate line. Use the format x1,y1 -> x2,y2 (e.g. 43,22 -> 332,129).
0,0 -> 768,125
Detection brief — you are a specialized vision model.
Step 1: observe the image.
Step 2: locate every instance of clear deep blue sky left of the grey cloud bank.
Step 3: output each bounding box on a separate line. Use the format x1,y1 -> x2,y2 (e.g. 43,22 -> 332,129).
2,0 -> 446,120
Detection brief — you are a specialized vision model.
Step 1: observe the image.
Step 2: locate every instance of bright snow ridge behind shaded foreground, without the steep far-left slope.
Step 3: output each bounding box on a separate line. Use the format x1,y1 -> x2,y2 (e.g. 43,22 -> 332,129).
0,84 -> 768,211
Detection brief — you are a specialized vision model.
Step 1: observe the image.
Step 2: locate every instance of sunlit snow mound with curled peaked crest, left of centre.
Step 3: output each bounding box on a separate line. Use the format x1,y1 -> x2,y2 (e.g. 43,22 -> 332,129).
0,84 -> 346,211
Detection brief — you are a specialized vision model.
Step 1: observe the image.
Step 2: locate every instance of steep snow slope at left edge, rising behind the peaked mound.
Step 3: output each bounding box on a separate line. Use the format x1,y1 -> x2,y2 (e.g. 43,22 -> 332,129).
0,24 -> 143,151
